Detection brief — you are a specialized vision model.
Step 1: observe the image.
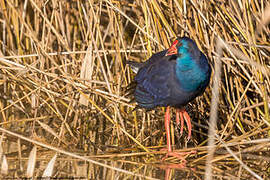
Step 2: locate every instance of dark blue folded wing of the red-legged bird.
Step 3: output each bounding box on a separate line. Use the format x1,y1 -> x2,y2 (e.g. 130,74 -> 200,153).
134,50 -> 175,109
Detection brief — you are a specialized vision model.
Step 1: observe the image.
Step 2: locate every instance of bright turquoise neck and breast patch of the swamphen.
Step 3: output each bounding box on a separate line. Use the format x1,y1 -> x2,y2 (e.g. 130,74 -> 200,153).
176,53 -> 206,91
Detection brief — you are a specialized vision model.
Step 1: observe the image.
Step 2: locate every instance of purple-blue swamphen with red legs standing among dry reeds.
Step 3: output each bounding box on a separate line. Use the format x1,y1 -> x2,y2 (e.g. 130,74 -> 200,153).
128,37 -> 211,160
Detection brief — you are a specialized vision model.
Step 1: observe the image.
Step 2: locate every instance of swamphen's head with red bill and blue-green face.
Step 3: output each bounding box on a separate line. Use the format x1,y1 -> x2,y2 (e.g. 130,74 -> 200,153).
165,37 -> 199,56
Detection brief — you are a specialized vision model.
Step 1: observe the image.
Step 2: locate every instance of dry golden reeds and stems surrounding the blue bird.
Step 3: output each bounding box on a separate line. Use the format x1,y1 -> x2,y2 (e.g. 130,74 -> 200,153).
0,0 -> 270,179
